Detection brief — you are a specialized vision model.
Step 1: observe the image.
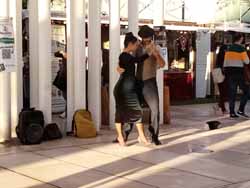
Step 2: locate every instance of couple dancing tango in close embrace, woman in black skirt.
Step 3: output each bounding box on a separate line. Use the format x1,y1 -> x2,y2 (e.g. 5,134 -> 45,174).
114,26 -> 165,146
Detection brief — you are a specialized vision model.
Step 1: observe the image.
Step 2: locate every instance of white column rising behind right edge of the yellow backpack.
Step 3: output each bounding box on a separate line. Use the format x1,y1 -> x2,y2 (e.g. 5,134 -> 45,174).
88,0 -> 102,131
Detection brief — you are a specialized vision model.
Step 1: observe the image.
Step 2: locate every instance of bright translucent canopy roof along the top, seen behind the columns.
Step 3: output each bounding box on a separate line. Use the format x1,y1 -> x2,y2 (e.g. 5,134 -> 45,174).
47,0 -> 250,23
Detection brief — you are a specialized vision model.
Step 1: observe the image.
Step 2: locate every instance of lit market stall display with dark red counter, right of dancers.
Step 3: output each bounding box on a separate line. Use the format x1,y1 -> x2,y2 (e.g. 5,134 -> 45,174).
164,31 -> 196,101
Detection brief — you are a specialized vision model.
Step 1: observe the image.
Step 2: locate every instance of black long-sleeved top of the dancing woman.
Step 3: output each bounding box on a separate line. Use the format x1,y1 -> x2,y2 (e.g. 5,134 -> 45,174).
119,52 -> 149,77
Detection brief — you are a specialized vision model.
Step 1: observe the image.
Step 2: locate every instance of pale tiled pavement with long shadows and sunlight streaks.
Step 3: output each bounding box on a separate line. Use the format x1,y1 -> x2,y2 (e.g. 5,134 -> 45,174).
0,104 -> 250,188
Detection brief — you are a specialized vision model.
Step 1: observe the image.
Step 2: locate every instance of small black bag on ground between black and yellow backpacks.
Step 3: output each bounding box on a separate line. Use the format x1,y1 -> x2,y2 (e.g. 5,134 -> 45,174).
43,123 -> 62,140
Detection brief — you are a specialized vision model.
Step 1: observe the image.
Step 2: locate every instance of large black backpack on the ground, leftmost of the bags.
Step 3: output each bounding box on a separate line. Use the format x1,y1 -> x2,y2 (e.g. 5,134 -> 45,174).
16,108 -> 44,144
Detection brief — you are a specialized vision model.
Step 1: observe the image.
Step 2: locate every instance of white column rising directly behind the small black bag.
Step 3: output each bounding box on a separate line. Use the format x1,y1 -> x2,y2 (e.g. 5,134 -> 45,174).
38,0 -> 52,123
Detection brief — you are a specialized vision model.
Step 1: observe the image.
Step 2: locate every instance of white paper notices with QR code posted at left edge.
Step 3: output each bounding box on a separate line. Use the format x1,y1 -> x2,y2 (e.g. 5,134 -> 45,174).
0,18 -> 17,72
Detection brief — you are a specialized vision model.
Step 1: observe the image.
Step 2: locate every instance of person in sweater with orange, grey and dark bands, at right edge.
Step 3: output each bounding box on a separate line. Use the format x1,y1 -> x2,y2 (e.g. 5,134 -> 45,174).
224,33 -> 249,118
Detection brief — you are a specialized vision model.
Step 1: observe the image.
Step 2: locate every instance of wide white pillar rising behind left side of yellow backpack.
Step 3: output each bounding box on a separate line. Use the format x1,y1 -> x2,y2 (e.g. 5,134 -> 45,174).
67,0 -> 86,131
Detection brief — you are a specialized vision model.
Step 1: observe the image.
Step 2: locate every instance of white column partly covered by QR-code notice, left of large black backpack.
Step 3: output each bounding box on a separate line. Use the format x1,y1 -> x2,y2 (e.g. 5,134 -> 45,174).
10,0 -> 23,135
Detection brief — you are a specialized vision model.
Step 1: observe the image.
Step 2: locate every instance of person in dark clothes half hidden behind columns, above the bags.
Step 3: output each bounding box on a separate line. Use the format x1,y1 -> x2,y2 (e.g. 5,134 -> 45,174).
53,51 -> 67,118
